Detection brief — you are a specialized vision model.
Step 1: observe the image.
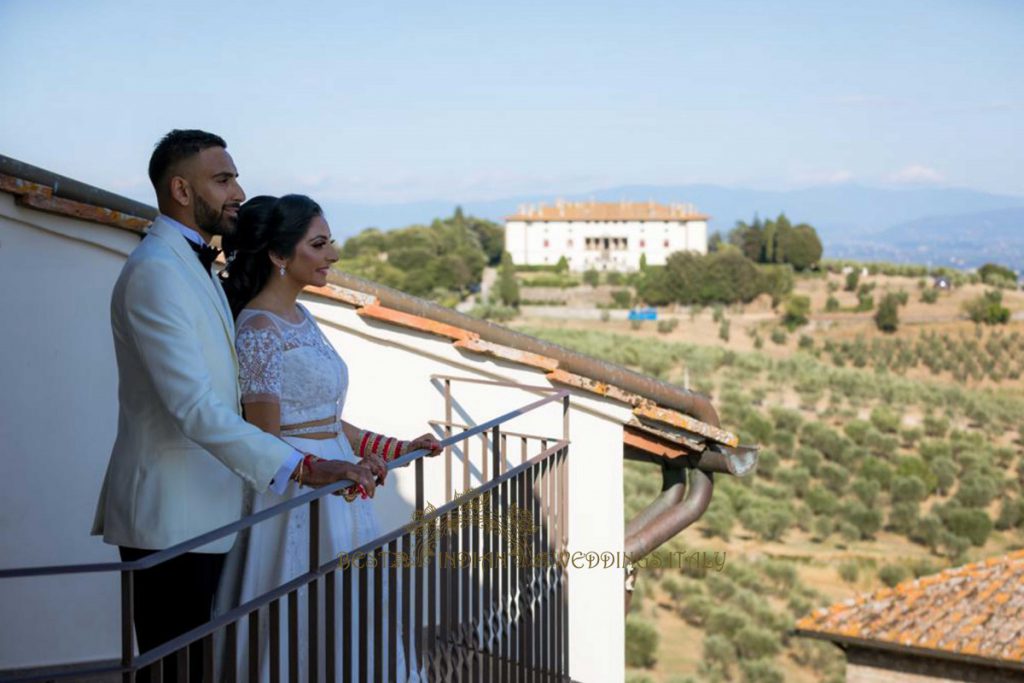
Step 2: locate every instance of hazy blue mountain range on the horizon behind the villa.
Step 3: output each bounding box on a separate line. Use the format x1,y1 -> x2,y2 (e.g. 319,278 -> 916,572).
324,184 -> 1024,270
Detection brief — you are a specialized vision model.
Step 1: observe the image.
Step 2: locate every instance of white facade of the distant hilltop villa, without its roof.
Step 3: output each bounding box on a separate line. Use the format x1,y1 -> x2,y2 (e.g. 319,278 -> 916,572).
505,220 -> 708,271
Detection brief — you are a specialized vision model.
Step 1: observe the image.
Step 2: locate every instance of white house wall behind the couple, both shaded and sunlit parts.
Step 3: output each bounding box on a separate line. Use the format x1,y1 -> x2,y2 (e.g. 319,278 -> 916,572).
0,200 -> 630,681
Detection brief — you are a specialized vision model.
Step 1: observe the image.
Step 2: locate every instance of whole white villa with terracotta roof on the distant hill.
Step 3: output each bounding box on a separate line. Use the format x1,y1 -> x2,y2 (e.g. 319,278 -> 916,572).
505,201 -> 708,271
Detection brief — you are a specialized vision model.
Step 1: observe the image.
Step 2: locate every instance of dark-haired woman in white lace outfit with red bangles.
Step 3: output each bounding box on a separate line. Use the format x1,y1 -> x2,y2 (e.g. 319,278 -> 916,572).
220,195 -> 440,681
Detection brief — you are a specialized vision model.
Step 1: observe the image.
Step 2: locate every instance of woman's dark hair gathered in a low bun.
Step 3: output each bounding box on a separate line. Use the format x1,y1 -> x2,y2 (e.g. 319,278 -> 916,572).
220,195 -> 324,317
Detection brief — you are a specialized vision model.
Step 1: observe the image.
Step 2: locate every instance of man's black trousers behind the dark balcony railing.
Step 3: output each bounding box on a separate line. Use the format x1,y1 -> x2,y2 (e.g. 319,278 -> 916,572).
119,546 -> 224,683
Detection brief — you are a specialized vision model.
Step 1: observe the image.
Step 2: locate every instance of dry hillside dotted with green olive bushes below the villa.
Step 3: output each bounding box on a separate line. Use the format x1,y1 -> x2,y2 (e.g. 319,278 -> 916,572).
520,278 -> 1024,683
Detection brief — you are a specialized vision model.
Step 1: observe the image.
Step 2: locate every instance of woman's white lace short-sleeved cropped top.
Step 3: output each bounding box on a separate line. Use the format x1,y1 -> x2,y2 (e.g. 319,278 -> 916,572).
234,304 -> 348,431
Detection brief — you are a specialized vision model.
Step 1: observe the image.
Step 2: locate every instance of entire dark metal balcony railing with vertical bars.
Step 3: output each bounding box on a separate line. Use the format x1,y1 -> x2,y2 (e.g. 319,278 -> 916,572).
0,376 -> 569,683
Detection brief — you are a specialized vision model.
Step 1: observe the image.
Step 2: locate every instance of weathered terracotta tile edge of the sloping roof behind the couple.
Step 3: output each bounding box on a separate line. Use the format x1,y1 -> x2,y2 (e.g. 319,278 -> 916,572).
0,165 -> 738,458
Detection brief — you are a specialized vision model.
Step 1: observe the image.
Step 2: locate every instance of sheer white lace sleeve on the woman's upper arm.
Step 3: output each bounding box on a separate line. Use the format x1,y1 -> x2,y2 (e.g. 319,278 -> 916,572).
234,315 -> 285,403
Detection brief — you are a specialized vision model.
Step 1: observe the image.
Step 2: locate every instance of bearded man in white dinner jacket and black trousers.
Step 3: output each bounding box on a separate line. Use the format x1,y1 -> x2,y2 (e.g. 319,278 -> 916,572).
92,130 -> 374,683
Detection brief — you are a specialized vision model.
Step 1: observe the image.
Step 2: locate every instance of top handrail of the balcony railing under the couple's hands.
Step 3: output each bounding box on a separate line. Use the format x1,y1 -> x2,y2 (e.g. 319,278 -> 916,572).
0,387 -> 569,580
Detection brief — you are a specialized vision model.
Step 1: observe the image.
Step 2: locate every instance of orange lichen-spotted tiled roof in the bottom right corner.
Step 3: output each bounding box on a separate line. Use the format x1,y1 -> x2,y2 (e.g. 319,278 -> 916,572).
797,550 -> 1024,666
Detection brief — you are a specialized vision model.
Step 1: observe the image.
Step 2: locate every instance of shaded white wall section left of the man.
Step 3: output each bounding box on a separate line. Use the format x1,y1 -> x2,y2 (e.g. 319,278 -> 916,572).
0,194 -> 139,669
